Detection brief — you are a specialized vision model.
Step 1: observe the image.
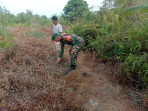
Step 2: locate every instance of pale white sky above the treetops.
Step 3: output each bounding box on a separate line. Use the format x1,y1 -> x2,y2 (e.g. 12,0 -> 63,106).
0,0 -> 103,17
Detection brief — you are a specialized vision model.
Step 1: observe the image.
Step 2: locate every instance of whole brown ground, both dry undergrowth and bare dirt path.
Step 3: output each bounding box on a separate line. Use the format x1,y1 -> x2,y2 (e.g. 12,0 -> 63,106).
0,25 -> 147,111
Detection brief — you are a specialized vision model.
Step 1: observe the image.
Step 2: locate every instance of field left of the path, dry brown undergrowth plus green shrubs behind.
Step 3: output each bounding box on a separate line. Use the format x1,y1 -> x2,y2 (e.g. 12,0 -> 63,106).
0,7 -> 91,111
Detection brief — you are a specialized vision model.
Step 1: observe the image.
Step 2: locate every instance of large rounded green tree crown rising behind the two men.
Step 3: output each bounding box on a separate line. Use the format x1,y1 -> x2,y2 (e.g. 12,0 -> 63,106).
63,0 -> 89,21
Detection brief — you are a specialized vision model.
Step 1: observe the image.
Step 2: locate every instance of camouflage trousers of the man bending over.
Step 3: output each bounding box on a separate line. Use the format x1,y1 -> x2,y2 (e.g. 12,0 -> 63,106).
69,42 -> 84,66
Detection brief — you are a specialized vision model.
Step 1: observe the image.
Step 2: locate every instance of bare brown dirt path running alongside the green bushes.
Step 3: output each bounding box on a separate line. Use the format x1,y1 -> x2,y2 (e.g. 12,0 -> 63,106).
65,46 -> 145,111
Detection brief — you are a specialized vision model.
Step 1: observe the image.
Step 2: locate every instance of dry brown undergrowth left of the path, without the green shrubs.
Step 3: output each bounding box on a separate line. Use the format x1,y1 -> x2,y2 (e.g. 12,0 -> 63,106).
0,27 -> 88,111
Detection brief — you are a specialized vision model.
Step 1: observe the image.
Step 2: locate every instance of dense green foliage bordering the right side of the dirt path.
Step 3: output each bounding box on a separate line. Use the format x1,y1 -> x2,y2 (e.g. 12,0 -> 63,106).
64,0 -> 148,88
